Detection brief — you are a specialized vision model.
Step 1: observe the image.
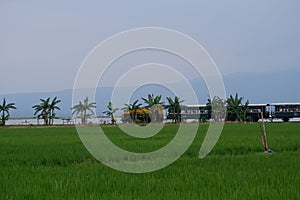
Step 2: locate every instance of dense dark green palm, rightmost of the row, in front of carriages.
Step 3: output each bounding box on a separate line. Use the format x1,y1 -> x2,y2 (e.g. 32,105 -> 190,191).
227,93 -> 249,121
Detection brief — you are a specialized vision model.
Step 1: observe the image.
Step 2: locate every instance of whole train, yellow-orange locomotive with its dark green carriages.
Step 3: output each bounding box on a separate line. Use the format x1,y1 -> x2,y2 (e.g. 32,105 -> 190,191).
124,103 -> 300,123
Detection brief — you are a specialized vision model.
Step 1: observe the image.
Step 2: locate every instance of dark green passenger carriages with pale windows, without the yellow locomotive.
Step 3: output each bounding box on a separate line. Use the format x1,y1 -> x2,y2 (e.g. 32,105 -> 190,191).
166,103 -> 300,122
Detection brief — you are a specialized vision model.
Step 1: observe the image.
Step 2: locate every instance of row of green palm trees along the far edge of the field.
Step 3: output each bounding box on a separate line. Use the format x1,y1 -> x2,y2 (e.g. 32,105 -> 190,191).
0,93 -> 249,126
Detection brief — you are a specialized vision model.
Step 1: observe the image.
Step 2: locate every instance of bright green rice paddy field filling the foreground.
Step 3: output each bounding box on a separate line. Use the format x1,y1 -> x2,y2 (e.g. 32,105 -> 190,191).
0,122 -> 300,199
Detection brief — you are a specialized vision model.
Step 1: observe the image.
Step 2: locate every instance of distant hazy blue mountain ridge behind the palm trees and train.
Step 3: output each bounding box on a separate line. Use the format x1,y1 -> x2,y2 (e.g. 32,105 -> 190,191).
0,69 -> 300,117
